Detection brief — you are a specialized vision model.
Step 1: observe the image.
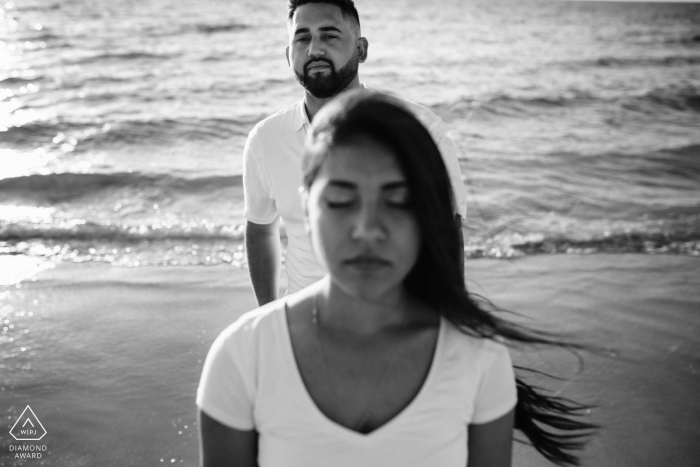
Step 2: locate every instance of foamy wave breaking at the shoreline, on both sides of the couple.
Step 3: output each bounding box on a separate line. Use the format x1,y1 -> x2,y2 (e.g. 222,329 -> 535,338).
0,223 -> 700,267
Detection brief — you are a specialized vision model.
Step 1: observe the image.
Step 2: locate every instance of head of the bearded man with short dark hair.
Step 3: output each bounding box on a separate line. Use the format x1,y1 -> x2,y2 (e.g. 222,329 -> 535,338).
287,3 -> 366,99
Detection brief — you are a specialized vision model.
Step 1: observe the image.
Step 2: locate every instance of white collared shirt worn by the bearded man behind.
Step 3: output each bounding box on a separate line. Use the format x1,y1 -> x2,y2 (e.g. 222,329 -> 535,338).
243,88 -> 467,293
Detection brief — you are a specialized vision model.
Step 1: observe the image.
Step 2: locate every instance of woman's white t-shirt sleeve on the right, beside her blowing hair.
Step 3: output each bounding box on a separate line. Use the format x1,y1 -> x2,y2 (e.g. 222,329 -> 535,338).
472,342 -> 518,424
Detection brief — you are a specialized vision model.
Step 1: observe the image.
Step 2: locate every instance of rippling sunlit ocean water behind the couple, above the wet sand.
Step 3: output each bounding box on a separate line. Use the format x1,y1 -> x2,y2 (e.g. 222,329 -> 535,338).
0,0 -> 700,267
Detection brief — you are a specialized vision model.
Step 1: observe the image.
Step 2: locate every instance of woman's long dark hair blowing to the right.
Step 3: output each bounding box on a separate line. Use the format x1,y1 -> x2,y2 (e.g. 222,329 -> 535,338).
303,90 -> 596,465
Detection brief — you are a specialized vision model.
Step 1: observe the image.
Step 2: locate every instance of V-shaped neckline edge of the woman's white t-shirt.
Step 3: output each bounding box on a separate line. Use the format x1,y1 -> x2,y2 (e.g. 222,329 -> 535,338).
280,302 -> 445,440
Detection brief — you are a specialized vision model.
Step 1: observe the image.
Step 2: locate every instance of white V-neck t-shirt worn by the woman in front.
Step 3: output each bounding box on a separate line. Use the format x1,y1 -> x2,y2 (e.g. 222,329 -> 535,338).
197,300 -> 516,467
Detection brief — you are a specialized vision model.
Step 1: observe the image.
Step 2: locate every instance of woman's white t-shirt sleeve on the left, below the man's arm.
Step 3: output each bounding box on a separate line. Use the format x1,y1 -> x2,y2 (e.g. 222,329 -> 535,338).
197,325 -> 255,430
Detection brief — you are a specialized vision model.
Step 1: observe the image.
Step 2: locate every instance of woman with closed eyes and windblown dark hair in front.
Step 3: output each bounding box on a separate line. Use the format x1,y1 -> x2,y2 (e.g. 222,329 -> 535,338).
197,91 -> 591,467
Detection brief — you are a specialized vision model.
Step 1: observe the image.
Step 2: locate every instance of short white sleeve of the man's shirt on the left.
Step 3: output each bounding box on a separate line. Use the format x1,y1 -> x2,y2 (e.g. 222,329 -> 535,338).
243,127 -> 277,224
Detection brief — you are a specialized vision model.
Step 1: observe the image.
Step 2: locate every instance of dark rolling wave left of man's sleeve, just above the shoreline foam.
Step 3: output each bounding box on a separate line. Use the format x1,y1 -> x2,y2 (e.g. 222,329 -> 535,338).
0,172 -> 243,203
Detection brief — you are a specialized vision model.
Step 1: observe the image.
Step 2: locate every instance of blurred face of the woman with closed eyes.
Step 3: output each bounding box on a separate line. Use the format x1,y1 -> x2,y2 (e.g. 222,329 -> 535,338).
305,137 -> 420,298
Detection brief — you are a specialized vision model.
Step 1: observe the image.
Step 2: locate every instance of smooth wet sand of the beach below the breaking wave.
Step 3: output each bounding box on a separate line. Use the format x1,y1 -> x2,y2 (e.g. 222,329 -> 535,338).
0,255 -> 700,467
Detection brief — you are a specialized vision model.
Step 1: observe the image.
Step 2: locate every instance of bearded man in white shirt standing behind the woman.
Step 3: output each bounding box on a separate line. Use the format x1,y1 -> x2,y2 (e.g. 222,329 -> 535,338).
243,0 -> 466,305
